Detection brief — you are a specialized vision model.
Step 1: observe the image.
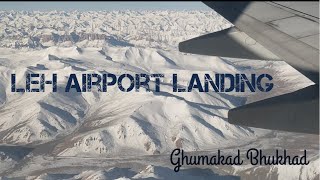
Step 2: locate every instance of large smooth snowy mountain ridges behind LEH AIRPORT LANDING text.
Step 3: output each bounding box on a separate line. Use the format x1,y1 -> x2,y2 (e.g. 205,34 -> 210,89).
0,47 -> 260,153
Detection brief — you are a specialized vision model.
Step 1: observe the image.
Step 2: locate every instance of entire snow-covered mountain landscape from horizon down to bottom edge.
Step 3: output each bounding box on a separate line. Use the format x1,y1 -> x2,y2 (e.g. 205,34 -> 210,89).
0,11 -> 319,179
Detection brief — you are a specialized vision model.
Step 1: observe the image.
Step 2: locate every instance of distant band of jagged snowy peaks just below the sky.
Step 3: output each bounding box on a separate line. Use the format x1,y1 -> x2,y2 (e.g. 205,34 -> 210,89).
0,10 -> 231,49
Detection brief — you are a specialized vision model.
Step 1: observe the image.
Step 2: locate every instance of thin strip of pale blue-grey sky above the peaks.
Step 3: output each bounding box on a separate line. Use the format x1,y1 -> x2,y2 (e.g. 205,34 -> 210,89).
0,1 -> 210,11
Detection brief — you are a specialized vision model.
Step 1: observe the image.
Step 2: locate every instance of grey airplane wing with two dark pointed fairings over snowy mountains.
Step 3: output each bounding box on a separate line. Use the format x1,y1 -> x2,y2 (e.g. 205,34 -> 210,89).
179,1 -> 319,134
